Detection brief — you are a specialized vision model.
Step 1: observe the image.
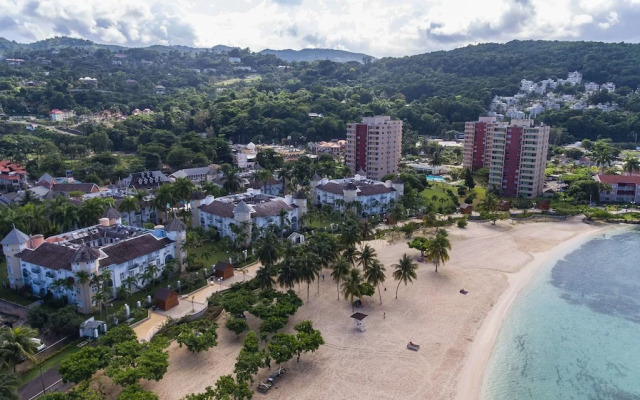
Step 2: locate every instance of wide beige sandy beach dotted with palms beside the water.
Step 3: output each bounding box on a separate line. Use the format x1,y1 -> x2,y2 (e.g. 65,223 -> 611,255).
143,219 -> 609,400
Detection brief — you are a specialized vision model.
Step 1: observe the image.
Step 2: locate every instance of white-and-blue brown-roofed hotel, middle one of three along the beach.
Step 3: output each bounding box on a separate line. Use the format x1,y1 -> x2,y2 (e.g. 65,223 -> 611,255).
198,189 -> 307,241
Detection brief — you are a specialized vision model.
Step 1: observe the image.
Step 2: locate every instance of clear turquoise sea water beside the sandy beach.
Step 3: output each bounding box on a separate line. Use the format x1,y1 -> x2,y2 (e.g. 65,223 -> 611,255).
480,230 -> 640,400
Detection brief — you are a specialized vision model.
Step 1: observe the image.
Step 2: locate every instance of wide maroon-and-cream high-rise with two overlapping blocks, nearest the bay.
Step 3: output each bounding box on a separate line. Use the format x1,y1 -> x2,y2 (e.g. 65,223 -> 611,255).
462,117 -> 550,198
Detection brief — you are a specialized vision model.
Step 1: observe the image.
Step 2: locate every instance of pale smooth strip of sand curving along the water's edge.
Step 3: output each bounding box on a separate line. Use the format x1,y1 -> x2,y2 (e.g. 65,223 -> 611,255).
455,225 -> 616,400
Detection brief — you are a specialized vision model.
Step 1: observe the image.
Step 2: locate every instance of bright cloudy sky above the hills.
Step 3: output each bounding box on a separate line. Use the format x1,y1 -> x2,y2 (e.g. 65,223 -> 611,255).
0,0 -> 640,57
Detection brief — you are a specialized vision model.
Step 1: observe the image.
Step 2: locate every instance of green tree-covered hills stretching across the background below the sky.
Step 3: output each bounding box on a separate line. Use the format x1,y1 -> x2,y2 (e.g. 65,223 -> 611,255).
0,38 -> 640,167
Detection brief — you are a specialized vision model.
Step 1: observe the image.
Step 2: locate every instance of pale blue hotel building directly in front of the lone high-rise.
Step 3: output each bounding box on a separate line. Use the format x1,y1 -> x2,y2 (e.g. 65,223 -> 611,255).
311,175 -> 404,217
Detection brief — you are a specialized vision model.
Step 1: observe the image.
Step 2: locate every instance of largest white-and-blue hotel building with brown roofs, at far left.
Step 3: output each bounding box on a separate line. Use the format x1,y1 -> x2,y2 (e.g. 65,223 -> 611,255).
1,214 -> 186,313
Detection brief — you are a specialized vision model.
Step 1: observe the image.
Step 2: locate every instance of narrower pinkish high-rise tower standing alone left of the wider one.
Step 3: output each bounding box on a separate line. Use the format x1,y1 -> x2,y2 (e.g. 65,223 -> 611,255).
345,116 -> 402,180
